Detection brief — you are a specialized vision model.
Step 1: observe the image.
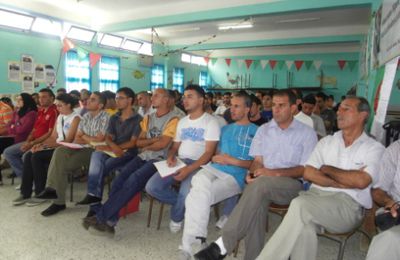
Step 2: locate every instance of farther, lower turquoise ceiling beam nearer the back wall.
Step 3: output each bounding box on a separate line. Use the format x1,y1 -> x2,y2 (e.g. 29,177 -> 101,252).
169,34 -> 365,51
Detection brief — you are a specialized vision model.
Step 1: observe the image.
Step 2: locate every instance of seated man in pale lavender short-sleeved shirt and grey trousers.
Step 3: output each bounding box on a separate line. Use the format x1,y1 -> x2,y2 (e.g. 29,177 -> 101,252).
195,89 -> 317,259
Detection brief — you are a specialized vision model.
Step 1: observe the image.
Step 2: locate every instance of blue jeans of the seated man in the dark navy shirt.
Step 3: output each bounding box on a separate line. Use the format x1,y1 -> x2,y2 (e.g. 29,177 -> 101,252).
88,151 -> 134,198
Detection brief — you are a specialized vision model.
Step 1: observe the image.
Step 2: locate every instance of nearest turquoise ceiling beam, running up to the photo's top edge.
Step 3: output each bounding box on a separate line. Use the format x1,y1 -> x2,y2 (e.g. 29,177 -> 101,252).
100,0 -> 374,32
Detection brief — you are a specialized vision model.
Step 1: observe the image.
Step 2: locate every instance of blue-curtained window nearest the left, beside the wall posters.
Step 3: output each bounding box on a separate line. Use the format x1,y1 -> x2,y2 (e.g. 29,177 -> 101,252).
65,51 -> 90,92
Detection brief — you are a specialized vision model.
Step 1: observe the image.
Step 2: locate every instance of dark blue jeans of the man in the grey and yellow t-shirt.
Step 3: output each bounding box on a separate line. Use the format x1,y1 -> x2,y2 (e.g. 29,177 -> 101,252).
94,156 -> 157,226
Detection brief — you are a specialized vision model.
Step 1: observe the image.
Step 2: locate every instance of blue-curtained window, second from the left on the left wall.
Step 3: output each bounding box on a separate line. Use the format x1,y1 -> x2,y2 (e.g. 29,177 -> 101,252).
99,56 -> 119,92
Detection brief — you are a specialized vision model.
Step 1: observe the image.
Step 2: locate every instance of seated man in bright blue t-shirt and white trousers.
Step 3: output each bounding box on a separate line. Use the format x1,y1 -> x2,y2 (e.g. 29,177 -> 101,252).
182,92 -> 257,259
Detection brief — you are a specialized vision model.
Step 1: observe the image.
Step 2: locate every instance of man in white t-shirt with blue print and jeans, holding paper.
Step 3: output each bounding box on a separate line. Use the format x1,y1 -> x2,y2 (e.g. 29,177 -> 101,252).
146,85 -> 220,233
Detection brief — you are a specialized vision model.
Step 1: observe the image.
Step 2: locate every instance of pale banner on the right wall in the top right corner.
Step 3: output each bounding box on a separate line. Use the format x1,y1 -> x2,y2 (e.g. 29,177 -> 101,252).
375,0 -> 400,65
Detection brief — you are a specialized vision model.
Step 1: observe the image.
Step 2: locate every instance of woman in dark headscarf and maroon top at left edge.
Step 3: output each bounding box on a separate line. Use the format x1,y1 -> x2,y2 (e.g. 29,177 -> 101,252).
0,93 -> 37,185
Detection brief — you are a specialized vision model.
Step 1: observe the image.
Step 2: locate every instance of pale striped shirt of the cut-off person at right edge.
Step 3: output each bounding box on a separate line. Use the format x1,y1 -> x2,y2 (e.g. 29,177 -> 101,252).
374,140 -> 400,201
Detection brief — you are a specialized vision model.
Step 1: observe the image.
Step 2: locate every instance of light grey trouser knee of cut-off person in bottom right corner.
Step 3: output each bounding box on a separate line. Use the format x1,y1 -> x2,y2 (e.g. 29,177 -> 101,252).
366,222 -> 400,260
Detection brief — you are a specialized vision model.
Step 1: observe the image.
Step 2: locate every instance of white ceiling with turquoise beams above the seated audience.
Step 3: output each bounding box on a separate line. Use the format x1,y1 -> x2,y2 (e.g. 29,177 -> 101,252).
0,0 -> 374,57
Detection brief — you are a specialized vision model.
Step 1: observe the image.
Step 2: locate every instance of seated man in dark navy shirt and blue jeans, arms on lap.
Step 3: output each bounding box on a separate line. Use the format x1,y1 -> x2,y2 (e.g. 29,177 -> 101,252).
77,87 -> 142,215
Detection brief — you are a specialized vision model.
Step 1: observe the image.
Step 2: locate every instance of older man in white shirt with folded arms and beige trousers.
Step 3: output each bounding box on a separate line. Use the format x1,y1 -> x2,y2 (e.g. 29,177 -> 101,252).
253,97 -> 384,260
